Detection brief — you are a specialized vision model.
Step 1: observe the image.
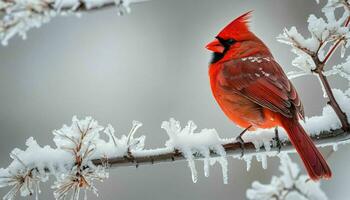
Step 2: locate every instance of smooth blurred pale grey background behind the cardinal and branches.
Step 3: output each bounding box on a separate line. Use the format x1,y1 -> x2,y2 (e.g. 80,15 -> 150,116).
0,0 -> 350,200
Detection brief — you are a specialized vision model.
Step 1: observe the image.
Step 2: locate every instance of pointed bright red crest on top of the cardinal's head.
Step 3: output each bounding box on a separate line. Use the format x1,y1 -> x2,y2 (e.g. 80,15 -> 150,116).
218,11 -> 252,39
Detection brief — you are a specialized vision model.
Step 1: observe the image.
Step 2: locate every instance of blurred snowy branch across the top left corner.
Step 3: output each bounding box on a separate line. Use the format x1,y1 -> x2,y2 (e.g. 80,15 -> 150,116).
0,0 -> 147,45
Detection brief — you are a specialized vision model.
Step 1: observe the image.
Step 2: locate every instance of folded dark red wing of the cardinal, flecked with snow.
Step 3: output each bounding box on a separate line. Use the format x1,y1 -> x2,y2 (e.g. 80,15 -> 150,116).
218,57 -> 304,118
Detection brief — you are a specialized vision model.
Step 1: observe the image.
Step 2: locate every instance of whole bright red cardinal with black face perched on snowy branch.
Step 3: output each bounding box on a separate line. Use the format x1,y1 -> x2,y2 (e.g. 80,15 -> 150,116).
206,12 -> 332,180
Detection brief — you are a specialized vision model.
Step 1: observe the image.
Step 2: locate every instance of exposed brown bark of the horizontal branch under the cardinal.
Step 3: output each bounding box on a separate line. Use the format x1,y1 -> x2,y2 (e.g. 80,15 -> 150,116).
93,128 -> 350,168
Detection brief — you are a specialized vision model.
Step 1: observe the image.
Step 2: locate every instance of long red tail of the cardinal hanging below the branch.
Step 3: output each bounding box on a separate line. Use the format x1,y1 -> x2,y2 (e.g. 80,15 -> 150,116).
281,118 -> 332,180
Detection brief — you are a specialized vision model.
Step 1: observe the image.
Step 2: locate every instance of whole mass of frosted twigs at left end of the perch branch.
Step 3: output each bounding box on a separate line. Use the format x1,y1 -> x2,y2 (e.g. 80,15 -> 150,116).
0,117 -> 145,200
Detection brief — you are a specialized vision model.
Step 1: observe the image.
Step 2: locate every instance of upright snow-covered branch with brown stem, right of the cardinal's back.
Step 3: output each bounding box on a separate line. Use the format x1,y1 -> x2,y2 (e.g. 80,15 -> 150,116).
277,0 -> 350,131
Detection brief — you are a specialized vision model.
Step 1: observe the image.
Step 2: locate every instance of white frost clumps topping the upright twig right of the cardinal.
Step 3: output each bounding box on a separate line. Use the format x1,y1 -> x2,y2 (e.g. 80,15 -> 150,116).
277,1 -> 350,78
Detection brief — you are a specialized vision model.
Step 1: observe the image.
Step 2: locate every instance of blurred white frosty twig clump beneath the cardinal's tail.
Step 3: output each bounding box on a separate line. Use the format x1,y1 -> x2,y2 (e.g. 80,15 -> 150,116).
246,154 -> 327,200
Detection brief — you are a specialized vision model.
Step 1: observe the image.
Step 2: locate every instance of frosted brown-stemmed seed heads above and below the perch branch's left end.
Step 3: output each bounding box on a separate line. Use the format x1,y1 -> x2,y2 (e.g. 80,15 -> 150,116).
53,117 -> 108,200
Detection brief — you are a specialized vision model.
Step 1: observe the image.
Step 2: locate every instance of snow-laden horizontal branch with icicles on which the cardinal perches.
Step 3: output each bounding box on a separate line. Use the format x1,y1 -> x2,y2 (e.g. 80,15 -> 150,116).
0,90 -> 350,200
